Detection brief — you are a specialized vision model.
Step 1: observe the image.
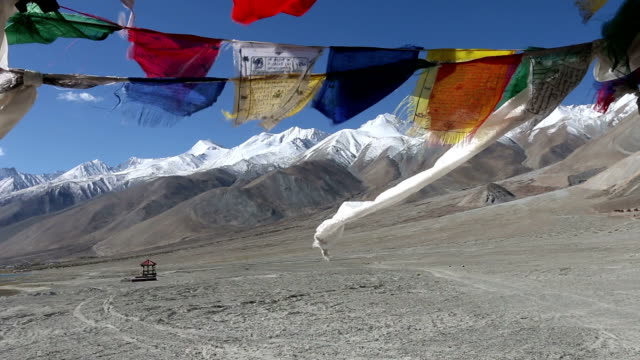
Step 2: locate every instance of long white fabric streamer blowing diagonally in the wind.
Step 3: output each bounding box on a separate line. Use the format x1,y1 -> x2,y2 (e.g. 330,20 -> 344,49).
313,87 -> 537,260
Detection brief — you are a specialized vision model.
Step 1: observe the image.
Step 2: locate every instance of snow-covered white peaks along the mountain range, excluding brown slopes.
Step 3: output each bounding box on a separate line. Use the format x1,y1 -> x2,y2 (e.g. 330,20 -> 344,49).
0,96 -> 636,212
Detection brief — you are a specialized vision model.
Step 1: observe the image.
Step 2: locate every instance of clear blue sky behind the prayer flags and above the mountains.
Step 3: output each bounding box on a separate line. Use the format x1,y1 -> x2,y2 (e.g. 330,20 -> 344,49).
0,0 -> 622,173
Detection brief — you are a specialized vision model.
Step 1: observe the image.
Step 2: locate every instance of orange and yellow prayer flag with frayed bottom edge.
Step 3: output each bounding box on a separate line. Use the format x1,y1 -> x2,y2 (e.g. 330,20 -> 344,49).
407,49 -> 522,144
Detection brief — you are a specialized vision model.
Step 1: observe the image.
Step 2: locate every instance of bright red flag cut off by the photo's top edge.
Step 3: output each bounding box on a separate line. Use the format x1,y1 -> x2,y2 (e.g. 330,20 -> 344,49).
231,0 -> 316,25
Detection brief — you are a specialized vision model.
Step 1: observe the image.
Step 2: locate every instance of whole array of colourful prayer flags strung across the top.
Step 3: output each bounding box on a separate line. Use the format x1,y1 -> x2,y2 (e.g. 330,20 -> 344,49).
0,0 -> 640,148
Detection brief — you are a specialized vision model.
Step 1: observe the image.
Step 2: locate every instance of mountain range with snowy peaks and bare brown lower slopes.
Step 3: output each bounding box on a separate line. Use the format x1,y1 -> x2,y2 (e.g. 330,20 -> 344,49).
0,96 -> 637,263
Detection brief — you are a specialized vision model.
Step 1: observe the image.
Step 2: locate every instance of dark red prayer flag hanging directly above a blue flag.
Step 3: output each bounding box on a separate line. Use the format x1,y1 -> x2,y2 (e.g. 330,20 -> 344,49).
127,28 -> 222,77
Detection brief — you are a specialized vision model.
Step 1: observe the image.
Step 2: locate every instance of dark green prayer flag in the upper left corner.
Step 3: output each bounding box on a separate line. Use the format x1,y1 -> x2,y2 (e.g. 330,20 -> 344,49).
5,4 -> 122,44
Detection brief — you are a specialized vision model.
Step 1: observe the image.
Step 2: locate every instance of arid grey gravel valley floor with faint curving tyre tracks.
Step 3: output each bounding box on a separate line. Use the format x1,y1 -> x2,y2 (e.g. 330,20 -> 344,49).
0,181 -> 640,360
